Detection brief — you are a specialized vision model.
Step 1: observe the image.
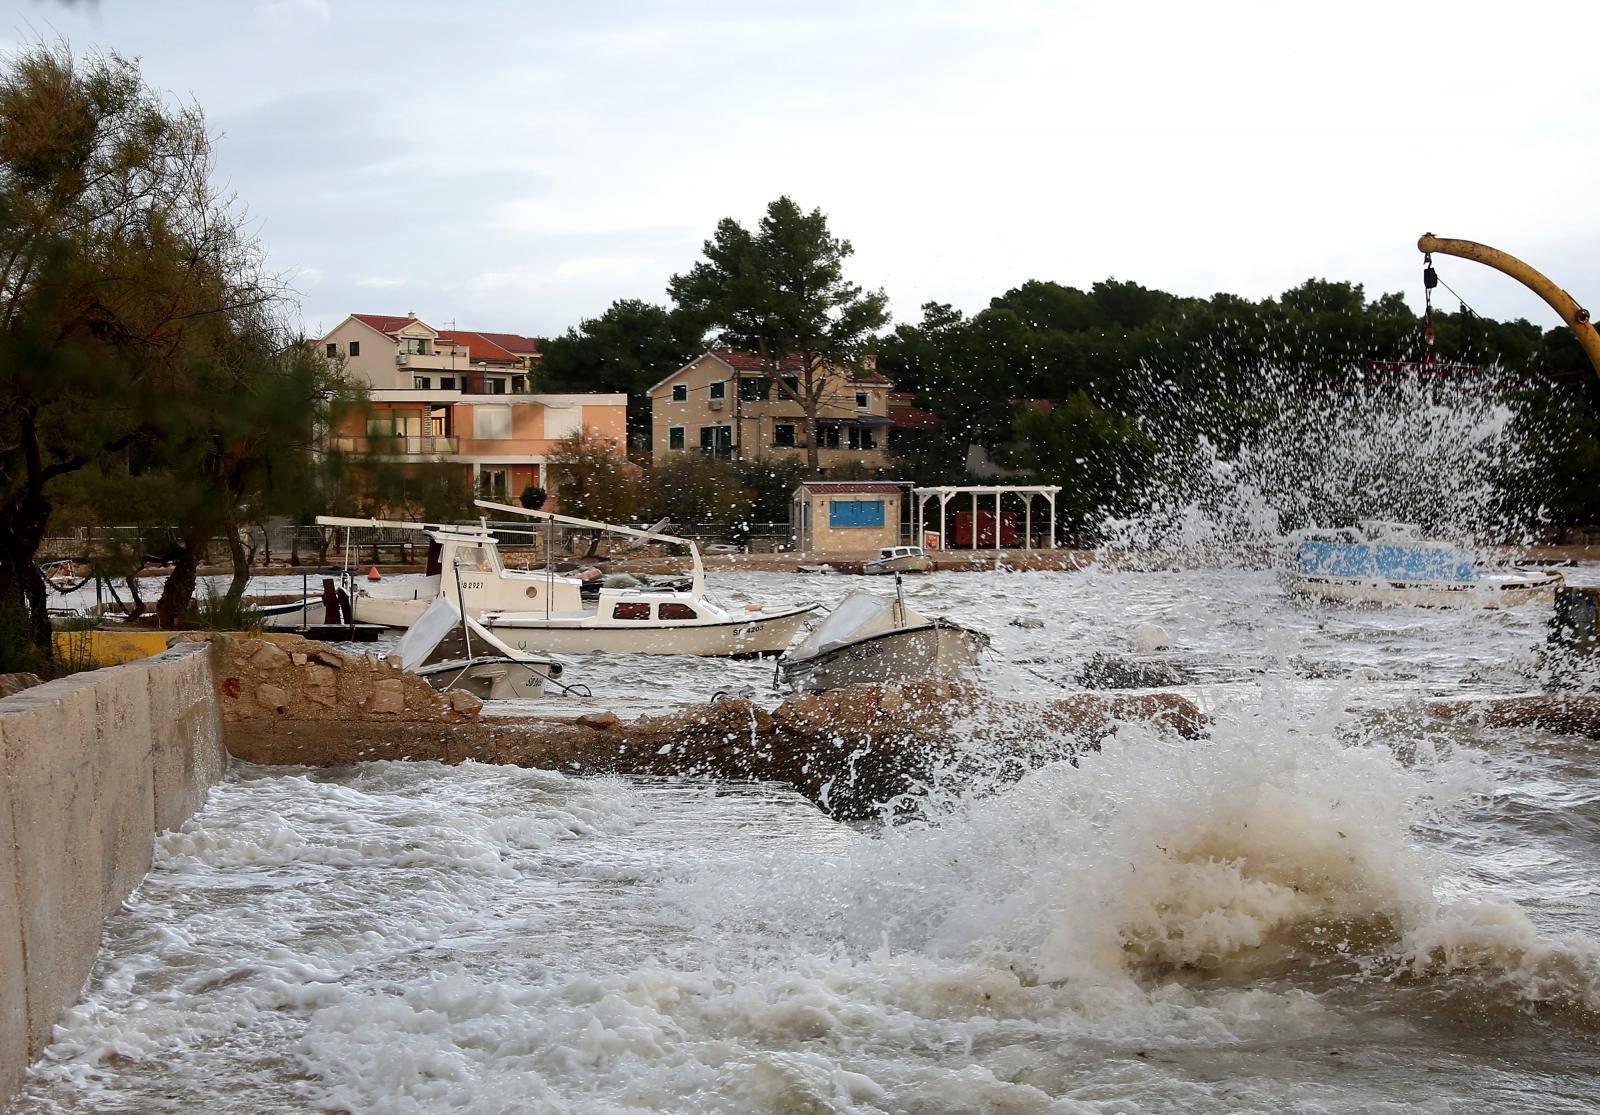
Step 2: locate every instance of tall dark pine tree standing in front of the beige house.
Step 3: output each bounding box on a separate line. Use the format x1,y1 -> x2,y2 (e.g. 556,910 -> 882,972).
667,195 -> 888,472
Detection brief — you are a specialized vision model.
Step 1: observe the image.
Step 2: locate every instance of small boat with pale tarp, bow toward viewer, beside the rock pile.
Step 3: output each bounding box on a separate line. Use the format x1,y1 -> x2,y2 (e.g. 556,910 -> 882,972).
398,597 -> 562,701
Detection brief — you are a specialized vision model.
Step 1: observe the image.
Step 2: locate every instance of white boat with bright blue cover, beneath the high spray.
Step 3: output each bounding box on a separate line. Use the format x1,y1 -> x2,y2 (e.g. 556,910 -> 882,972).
1286,520 -> 1563,608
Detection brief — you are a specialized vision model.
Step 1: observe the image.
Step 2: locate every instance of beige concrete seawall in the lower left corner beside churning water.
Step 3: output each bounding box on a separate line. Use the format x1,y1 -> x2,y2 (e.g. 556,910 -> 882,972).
0,643 -> 227,1107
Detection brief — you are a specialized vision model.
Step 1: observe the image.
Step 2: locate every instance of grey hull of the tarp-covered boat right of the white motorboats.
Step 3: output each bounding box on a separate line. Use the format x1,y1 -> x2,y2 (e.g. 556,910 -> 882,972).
782,621 -> 989,693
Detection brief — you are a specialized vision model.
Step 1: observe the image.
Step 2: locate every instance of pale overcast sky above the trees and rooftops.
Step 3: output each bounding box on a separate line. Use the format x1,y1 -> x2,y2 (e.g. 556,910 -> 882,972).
0,0 -> 1600,334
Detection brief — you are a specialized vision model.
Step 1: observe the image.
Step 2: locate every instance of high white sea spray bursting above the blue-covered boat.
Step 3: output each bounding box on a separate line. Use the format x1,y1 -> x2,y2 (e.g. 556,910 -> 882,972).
1101,370 -> 1542,565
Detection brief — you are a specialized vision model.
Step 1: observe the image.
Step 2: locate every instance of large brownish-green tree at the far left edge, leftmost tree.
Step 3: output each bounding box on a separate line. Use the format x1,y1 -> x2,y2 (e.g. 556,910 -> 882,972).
0,46 -> 277,657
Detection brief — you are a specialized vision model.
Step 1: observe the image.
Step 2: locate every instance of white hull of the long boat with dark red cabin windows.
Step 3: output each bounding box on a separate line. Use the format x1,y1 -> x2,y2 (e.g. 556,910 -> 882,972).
482,605 -> 816,657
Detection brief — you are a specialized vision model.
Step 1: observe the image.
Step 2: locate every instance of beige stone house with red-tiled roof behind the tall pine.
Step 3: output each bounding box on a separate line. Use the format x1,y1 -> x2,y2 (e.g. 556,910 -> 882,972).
648,349 -> 893,470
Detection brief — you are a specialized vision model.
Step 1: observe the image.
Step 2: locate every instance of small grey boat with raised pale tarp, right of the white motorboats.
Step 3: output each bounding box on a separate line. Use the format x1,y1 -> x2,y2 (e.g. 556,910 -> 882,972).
778,577 -> 989,693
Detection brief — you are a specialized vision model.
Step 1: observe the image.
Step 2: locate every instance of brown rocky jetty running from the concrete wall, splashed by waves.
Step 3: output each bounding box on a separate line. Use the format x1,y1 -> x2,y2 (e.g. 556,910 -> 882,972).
203,638 -> 1205,817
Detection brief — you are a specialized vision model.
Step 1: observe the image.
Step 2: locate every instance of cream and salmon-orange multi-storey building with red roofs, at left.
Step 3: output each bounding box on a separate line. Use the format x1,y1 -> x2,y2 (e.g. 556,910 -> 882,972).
320,314 -> 627,499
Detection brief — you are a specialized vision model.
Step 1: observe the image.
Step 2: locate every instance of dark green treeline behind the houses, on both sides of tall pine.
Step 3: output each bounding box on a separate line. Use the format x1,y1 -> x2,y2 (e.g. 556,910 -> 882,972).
546,262 -> 1600,539
